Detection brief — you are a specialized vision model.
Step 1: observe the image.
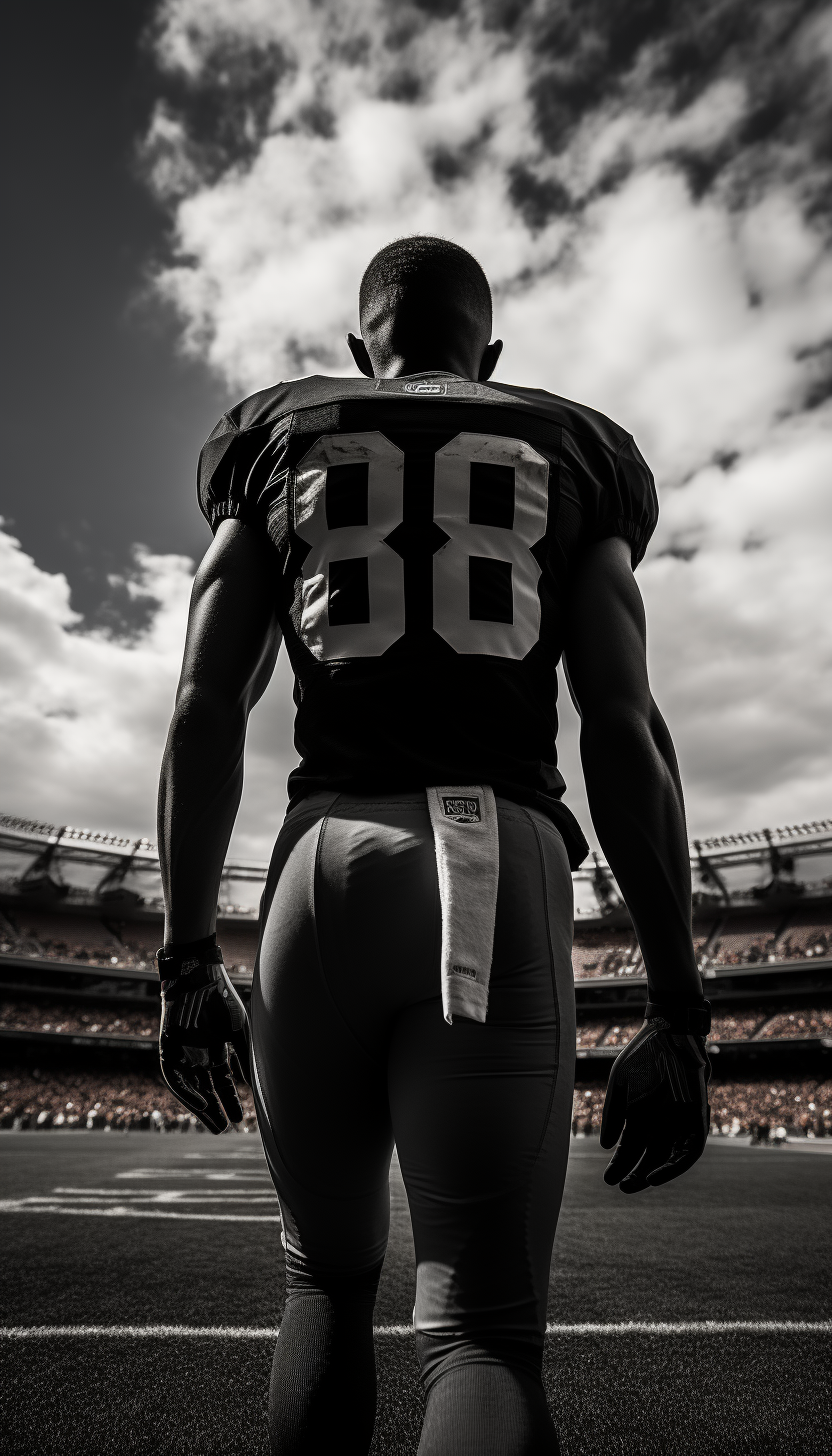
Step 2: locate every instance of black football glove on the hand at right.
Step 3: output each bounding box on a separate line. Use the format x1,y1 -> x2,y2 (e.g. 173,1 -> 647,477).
600,1002 -> 711,1192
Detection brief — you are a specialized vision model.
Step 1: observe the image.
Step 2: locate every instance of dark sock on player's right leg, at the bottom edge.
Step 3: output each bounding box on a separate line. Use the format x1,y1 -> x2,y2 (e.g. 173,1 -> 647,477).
418,1361 -> 561,1456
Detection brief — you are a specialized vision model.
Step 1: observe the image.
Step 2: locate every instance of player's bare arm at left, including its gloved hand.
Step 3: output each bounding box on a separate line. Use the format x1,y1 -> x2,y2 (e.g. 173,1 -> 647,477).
159,520 -> 281,1133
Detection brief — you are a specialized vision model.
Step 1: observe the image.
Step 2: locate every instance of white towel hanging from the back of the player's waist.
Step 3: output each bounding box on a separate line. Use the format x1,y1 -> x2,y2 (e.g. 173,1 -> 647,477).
427,783 -> 500,1024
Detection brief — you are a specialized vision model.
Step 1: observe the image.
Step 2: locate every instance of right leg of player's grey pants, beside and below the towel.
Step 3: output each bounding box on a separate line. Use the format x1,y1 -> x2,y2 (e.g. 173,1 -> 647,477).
389,802 -> 574,1340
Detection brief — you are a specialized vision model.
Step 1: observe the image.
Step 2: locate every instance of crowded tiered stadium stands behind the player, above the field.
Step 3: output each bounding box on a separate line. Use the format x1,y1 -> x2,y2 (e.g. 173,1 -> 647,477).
0,815 -> 832,1143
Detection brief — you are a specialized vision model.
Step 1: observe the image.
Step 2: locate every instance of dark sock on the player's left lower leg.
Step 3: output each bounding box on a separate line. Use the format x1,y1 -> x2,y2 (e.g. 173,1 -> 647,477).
268,1270 -> 379,1456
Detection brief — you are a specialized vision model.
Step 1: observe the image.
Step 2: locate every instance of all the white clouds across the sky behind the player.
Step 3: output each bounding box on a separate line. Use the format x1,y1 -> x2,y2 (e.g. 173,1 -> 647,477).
0,0 -> 832,858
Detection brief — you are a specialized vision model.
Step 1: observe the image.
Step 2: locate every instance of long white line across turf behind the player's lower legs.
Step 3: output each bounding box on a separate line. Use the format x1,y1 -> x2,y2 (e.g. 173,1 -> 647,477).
0,1319 -> 832,1340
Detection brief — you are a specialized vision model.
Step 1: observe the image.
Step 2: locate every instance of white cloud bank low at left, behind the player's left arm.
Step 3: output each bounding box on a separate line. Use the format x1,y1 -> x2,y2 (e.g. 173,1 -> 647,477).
0,530 -> 296,859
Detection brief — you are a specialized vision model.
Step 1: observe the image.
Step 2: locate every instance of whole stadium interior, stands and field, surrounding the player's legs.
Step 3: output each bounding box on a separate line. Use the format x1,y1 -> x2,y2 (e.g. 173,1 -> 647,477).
0,817 -> 832,1456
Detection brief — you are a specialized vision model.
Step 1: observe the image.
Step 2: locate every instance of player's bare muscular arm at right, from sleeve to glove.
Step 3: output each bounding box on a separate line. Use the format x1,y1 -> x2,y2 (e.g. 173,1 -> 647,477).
565,537 -> 702,1003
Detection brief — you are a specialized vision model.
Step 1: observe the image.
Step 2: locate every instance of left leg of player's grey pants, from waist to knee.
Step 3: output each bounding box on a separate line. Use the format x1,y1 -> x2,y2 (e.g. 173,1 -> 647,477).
252,795 -> 441,1271
